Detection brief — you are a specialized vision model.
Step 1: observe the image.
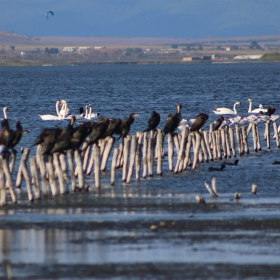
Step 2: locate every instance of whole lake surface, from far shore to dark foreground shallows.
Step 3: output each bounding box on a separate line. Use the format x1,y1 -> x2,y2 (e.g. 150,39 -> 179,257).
0,63 -> 280,279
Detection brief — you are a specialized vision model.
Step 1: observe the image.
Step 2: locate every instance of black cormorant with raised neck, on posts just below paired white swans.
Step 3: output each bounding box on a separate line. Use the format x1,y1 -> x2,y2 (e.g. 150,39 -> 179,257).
51,116 -> 78,153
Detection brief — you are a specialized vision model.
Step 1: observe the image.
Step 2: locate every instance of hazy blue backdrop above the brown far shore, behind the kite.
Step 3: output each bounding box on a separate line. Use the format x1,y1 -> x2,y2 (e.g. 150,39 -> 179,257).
0,0 -> 280,38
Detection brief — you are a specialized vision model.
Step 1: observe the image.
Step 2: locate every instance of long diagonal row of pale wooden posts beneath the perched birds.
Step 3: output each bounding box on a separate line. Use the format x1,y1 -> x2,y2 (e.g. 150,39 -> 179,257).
0,118 -> 280,206
